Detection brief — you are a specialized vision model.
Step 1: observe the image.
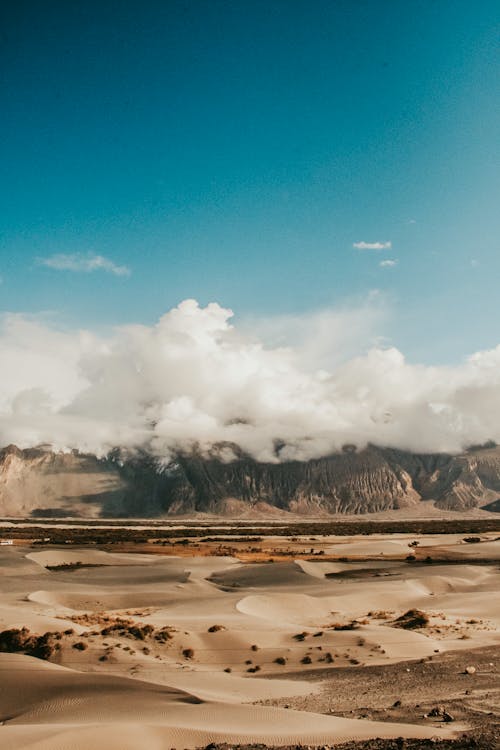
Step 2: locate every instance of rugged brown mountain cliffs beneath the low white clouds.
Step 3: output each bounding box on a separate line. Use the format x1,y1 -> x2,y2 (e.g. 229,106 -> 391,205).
0,446 -> 500,517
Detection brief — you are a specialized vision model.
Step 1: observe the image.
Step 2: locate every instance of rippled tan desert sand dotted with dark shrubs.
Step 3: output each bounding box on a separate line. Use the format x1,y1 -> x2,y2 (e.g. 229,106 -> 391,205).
0,534 -> 500,750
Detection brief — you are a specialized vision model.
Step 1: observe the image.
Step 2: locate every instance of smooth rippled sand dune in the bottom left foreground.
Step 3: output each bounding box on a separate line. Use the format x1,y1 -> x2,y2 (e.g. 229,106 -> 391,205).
0,654 -> 453,747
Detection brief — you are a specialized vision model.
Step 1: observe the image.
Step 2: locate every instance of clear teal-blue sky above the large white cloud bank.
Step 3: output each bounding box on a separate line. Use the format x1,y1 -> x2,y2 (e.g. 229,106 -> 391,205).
0,0 -> 500,362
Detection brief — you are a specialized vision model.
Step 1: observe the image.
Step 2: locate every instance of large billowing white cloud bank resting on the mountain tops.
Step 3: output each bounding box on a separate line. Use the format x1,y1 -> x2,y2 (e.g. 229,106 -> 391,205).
0,300 -> 500,461
